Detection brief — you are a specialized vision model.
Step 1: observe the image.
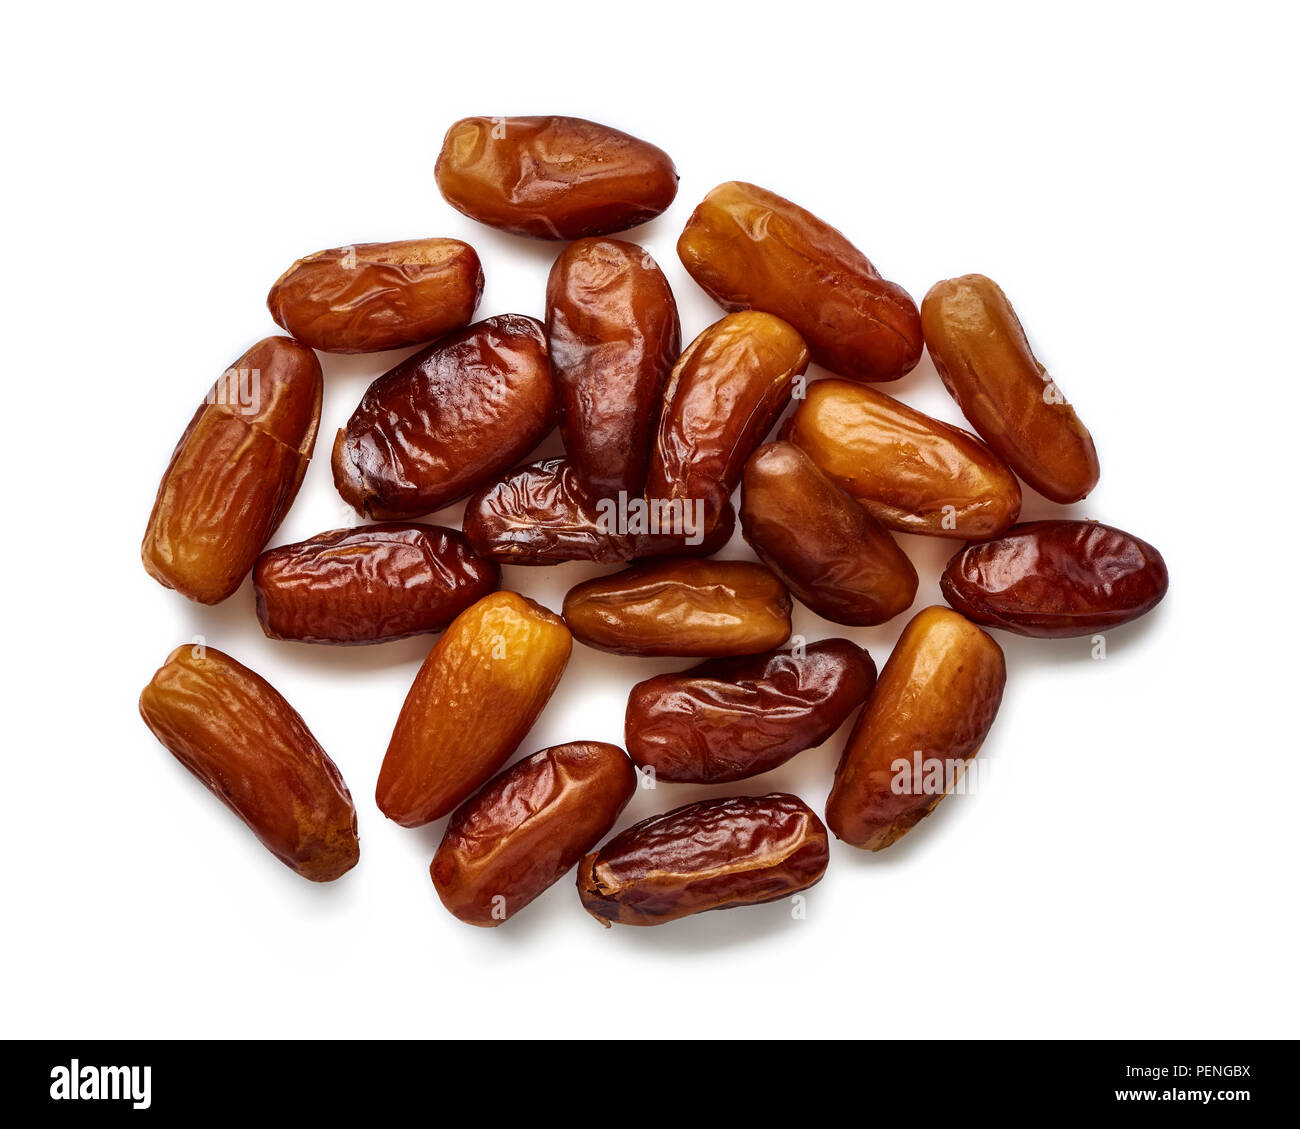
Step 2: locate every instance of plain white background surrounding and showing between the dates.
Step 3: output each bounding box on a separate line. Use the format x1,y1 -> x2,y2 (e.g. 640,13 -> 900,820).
0,3 -> 1300,1037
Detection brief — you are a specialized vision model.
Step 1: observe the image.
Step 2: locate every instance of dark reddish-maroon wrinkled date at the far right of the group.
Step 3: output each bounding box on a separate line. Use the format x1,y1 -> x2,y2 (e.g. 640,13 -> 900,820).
939,520 -> 1169,639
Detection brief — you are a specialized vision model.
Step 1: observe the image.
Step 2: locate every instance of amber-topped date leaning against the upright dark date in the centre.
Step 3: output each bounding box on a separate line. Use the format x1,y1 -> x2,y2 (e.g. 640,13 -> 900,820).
646,312 -> 809,524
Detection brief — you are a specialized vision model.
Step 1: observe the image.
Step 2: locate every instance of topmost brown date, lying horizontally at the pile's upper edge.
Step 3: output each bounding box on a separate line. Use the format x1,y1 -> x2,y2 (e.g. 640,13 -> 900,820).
434,117 -> 677,239
